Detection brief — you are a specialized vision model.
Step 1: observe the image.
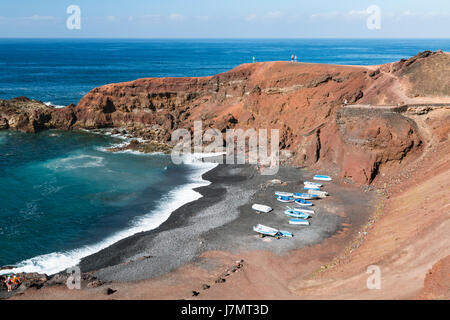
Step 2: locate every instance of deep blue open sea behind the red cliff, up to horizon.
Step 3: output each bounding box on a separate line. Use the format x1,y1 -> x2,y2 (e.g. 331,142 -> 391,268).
0,39 -> 450,105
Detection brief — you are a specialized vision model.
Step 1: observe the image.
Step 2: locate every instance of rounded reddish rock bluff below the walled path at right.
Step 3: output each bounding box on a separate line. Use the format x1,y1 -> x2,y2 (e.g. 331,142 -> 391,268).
336,108 -> 422,183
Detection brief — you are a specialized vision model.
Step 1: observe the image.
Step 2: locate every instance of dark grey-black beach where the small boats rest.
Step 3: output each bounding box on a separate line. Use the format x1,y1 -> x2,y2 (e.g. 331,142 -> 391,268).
80,164 -> 375,282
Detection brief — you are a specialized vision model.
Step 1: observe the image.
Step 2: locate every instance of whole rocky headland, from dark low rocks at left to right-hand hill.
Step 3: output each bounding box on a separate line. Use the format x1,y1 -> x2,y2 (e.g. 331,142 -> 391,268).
0,52 -> 450,183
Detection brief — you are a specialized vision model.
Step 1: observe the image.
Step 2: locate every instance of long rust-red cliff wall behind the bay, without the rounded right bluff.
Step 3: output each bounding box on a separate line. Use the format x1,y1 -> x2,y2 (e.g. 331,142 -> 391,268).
74,62 -> 366,148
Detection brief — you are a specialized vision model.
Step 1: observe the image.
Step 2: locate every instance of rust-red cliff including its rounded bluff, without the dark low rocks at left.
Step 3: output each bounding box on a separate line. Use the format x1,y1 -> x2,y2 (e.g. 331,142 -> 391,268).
75,56 -> 432,183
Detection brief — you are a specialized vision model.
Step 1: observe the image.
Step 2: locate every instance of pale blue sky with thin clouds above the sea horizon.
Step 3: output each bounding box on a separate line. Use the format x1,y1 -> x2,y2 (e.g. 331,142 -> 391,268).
0,0 -> 450,38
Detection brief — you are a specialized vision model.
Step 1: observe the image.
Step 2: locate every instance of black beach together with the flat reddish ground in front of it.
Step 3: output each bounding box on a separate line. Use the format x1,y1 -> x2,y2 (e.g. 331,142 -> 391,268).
5,164 -> 377,300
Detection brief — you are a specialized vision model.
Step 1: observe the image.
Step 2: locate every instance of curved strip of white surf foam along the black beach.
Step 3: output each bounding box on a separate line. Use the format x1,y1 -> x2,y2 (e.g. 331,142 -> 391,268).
0,154 -> 217,275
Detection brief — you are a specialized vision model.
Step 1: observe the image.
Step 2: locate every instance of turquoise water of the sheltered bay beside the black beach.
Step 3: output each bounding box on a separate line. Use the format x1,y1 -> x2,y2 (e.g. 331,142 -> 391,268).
0,131 -> 214,272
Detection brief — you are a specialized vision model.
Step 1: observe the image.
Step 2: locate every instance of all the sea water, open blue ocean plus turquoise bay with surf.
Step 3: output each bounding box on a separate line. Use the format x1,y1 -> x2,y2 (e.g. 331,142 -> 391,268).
0,39 -> 450,274
